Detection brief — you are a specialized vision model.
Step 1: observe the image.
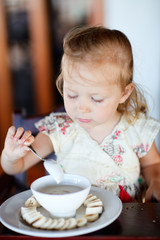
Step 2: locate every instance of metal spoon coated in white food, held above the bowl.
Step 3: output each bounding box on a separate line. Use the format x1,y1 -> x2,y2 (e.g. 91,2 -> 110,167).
29,145 -> 64,183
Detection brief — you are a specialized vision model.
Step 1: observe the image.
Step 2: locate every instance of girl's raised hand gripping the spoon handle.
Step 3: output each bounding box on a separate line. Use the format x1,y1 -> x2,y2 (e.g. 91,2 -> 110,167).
3,126 -> 34,162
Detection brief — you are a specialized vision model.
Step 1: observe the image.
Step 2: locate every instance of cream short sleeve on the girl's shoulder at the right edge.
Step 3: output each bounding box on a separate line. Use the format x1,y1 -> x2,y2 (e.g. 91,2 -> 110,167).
127,114 -> 160,158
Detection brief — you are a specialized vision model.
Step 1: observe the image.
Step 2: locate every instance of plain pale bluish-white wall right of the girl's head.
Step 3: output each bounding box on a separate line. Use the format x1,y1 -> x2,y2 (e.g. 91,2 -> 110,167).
104,0 -> 160,150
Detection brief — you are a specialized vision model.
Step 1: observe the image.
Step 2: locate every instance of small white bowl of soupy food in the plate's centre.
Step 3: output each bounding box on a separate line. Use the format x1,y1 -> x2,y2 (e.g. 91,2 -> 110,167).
31,174 -> 91,217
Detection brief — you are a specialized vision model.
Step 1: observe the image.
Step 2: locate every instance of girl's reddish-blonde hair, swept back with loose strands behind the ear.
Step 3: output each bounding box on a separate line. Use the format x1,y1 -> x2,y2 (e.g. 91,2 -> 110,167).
56,26 -> 148,123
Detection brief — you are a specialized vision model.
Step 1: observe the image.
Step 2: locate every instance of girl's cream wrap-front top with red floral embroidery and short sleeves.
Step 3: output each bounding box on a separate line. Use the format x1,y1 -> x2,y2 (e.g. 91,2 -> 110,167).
35,113 -> 160,201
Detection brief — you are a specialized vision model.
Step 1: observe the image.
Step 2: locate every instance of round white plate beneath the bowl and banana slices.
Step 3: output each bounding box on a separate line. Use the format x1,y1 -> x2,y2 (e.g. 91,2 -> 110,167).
0,187 -> 122,237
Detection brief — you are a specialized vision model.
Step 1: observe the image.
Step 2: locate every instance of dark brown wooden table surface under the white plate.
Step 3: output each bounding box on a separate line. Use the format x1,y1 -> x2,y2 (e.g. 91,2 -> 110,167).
0,203 -> 160,240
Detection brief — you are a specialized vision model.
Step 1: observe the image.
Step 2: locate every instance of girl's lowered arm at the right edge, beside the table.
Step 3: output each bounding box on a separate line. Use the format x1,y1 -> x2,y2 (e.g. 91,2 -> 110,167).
140,142 -> 160,202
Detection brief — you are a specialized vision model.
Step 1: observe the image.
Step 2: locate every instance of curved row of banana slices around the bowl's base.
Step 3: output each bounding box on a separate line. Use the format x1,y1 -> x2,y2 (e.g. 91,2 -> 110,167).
21,194 -> 103,231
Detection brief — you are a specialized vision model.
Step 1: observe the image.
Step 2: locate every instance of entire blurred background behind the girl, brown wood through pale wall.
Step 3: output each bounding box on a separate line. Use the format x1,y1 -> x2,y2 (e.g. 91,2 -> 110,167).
0,0 -> 160,186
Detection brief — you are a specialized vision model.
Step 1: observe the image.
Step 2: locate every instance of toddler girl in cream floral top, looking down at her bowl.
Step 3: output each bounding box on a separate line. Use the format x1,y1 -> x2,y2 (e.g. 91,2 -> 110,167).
1,26 -> 160,201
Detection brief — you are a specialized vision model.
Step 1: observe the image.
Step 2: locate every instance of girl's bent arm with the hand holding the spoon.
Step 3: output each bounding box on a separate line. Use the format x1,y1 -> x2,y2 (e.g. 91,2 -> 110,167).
1,126 -> 53,175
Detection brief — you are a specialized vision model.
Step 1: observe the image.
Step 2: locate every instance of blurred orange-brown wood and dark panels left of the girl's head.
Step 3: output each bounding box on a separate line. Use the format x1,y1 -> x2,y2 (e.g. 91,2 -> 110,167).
0,0 -> 104,161
